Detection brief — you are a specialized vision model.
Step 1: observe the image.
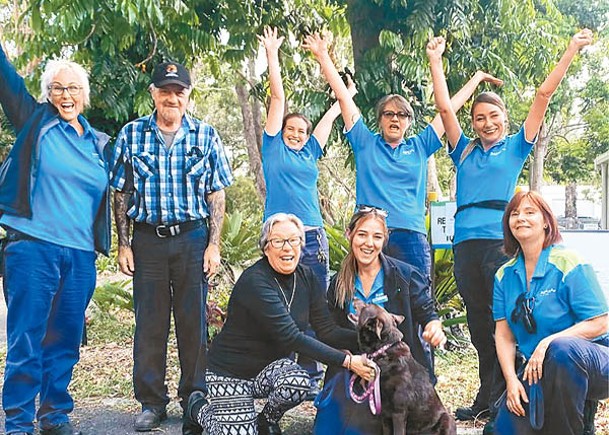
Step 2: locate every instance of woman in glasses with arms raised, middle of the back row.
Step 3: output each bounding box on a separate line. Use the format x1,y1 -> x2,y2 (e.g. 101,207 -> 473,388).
304,34 -> 502,278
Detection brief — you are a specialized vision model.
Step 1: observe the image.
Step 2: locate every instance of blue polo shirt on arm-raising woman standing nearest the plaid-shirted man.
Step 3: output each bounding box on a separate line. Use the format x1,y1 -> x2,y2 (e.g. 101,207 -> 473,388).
262,131 -> 323,227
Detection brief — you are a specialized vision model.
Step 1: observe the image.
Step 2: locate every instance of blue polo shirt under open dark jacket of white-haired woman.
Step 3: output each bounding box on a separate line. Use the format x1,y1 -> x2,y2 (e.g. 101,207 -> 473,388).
0,116 -> 108,251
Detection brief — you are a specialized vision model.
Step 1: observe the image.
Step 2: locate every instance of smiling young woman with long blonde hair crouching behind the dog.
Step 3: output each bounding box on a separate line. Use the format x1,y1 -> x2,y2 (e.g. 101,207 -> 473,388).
316,206 -> 446,434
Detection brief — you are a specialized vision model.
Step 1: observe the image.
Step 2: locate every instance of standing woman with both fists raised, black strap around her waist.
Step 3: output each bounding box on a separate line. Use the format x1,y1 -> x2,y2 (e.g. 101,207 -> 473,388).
427,30 -> 592,428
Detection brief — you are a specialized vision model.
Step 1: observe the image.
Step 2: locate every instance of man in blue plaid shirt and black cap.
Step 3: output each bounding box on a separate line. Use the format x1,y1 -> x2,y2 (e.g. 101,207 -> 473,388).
110,62 -> 232,435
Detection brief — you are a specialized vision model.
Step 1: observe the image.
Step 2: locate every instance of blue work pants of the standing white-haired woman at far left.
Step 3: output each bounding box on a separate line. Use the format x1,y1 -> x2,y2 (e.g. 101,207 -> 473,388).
2,237 -> 96,433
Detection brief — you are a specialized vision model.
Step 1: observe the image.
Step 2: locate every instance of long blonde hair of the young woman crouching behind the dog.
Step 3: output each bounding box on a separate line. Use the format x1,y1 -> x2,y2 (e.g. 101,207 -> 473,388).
335,208 -> 389,308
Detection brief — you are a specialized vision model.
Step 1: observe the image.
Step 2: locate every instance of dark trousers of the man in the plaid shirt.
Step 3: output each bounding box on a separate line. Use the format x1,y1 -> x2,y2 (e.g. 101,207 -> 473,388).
132,226 -> 208,410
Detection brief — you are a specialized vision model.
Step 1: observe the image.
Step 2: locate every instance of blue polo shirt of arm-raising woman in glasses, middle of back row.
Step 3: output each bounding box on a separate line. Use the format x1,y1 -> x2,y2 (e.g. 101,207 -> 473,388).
345,117 -> 442,234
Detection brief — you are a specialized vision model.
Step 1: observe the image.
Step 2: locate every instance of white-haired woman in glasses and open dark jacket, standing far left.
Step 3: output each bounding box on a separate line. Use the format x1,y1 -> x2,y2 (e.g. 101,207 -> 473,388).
0,41 -> 110,435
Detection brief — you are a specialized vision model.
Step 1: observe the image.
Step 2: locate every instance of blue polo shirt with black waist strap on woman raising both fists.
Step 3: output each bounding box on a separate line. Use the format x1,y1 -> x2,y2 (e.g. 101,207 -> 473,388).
449,126 -> 535,245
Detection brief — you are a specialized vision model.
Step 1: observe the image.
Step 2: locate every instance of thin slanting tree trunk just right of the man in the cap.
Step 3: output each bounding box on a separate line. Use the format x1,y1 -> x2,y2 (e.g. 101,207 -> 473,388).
235,84 -> 266,204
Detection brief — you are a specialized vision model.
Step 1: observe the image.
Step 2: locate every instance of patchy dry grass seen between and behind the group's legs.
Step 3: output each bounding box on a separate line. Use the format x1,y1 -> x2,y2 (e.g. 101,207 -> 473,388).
0,310 -> 609,435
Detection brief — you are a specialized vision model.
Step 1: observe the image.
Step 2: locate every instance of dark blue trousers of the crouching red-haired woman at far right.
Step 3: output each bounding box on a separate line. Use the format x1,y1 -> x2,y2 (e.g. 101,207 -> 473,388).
494,337 -> 609,435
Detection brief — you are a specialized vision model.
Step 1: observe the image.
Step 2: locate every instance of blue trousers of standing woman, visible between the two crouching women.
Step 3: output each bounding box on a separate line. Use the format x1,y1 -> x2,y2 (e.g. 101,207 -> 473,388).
298,228 -> 330,385
